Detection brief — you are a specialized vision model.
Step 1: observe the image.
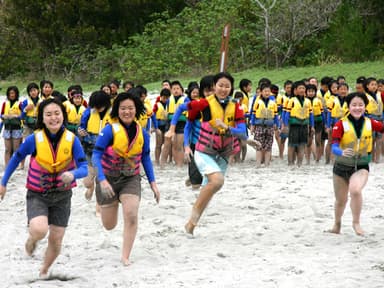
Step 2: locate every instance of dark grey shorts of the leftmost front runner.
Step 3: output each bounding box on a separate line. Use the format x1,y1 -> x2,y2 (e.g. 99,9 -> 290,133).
27,190 -> 72,227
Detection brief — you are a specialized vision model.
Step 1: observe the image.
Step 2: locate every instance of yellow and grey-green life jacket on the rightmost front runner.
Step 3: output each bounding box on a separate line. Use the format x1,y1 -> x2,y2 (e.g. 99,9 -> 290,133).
336,117 -> 373,166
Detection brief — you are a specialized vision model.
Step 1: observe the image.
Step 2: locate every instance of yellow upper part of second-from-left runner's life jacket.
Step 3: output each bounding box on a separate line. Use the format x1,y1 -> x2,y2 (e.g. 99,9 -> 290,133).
111,119 -> 144,158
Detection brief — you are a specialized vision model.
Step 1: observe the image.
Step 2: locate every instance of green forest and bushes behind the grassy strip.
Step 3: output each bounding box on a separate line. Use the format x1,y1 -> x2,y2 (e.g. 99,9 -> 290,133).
0,0 -> 384,88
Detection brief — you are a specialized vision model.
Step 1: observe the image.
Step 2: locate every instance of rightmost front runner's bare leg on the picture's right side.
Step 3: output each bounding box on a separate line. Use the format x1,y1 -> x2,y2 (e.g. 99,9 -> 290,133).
349,169 -> 368,235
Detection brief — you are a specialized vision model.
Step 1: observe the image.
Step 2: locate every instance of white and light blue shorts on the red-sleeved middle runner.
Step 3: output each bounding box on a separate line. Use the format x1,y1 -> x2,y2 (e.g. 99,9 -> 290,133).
194,151 -> 228,186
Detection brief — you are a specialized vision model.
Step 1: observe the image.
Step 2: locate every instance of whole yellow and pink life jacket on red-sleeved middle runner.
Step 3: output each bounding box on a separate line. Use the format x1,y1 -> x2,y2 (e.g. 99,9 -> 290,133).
196,95 -> 240,157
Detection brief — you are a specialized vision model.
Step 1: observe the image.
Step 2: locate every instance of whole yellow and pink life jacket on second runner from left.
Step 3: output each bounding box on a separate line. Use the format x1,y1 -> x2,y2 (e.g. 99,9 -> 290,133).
101,120 -> 144,177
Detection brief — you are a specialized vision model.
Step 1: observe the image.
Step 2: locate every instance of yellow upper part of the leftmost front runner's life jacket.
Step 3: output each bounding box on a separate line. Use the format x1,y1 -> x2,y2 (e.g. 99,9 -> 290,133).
34,129 -> 75,173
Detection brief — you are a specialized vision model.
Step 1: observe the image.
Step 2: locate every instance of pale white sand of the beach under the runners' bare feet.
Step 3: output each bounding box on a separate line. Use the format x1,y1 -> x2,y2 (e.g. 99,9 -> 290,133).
0,141 -> 384,288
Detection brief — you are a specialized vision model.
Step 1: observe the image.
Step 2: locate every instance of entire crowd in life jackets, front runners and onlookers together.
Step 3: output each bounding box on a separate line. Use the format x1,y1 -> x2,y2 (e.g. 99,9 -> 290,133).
0,72 -> 384,277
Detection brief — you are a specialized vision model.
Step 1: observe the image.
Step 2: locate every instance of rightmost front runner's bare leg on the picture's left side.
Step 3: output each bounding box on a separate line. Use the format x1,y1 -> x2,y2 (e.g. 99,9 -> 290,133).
328,174 -> 348,234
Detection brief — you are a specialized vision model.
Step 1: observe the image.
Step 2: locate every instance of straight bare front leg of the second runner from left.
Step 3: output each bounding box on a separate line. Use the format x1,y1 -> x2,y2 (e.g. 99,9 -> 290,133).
120,194 -> 140,265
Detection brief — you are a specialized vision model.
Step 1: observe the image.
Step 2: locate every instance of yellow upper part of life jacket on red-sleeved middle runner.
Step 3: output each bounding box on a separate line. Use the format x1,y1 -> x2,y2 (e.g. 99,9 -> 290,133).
206,95 -> 236,134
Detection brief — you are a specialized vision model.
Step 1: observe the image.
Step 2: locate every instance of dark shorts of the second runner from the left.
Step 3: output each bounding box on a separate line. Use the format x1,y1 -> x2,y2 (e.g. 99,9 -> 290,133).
96,174 -> 141,205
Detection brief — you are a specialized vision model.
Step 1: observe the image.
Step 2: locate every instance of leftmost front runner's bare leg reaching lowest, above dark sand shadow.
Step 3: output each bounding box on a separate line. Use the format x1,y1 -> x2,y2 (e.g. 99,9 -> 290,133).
40,225 -> 65,277
